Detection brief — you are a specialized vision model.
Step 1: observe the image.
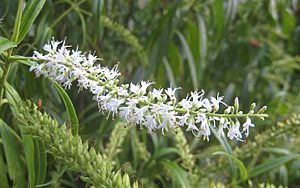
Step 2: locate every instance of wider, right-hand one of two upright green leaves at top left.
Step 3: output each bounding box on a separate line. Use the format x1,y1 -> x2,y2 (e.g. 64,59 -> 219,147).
16,0 -> 46,44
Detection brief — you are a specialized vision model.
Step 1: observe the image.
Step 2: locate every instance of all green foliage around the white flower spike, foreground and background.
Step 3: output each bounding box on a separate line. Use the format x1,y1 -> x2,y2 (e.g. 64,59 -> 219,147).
0,0 -> 300,187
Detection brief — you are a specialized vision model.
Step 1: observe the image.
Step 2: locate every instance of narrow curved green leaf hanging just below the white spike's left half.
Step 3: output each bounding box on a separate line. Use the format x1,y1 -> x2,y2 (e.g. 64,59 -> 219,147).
54,82 -> 79,136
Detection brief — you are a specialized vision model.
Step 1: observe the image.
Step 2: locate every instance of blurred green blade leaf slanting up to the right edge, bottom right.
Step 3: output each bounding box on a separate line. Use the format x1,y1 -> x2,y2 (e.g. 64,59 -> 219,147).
249,154 -> 300,178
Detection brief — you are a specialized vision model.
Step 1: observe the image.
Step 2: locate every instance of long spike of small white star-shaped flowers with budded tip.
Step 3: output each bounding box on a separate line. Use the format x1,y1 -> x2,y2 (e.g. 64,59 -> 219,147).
30,40 -> 267,140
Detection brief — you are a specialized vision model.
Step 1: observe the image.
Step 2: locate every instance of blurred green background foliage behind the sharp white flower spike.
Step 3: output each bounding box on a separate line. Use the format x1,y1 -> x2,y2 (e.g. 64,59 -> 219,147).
0,0 -> 300,187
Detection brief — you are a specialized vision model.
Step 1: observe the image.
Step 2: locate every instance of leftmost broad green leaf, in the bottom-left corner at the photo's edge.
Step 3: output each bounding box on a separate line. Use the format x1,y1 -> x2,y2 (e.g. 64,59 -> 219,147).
0,119 -> 25,188
